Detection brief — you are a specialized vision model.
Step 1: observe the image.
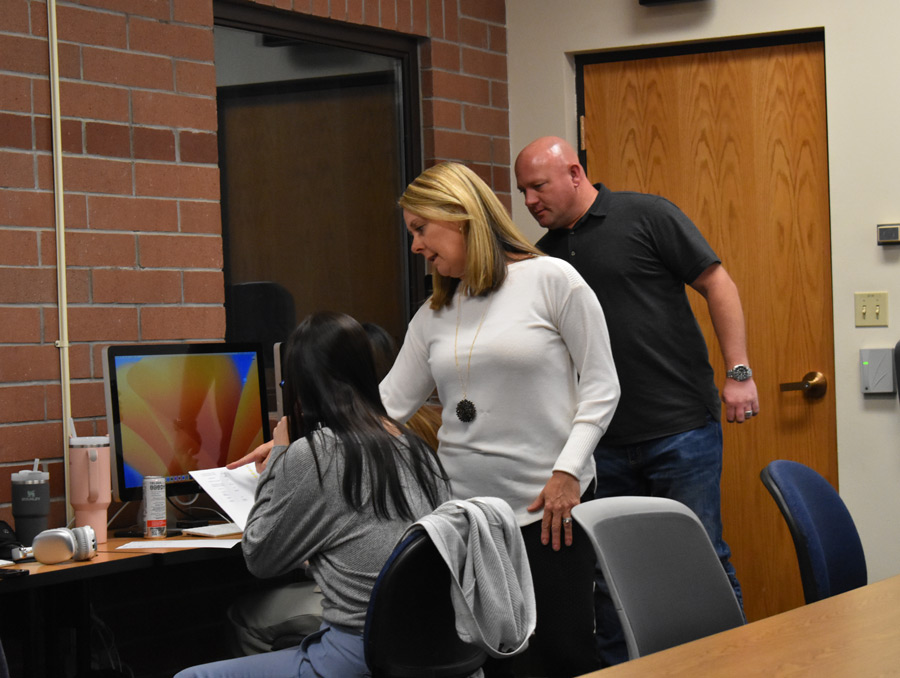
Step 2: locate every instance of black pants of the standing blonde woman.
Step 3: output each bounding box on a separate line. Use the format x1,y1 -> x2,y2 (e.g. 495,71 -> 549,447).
484,504 -> 600,678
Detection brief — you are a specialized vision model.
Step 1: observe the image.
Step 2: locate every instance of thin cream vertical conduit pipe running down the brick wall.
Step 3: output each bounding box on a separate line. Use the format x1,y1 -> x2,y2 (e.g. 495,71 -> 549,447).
47,0 -> 73,524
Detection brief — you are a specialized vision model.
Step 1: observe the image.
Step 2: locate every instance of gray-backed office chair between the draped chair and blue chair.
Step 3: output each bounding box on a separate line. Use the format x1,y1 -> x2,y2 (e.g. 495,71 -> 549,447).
572,497 -> 744,659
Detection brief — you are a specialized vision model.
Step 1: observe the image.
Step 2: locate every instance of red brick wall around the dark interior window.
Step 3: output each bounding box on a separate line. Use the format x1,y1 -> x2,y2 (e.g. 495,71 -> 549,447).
0,0 -> 510,526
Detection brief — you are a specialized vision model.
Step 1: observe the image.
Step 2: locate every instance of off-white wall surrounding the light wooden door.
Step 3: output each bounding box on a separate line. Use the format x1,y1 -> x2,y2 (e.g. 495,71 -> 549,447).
506,0 -> 900,581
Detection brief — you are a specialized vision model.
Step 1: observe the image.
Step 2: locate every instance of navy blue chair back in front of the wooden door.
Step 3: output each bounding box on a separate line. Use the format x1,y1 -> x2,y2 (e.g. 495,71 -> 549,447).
759,459 -> 867,603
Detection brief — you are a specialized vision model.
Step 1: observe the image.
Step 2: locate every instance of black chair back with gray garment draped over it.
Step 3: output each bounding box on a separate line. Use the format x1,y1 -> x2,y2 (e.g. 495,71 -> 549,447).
364,530 -> 487,678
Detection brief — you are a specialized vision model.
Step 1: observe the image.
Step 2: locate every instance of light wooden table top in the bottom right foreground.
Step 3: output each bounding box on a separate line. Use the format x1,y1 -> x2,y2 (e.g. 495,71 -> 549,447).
582,575 -> 900,678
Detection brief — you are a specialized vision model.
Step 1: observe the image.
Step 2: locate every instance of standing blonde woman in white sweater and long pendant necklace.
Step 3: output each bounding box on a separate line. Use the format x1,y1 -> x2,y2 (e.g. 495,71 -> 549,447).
381,163 -> 619,676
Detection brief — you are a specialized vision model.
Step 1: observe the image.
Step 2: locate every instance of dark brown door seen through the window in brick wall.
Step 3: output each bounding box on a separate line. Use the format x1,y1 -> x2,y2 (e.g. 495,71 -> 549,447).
219,73 -> 407,338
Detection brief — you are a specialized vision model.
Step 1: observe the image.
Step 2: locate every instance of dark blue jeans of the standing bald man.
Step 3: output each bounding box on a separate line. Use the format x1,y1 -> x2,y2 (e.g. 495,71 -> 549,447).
594,418 -> 743,665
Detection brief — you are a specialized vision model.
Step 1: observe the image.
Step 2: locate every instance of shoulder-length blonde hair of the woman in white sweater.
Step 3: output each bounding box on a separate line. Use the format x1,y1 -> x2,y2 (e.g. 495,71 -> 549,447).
398,162 -> 542,310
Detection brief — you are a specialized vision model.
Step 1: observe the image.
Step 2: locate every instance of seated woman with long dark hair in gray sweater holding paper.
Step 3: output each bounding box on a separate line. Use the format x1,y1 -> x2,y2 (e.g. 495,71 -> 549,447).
177,313 -> 447,678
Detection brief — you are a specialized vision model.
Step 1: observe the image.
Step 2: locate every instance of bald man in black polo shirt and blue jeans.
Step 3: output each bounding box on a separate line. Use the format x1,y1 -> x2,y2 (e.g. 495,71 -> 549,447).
515,137 -> 759,664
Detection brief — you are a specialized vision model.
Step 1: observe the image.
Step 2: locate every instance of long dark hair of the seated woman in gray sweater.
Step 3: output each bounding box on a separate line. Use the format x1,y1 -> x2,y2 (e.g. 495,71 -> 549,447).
284,312 -> 447,520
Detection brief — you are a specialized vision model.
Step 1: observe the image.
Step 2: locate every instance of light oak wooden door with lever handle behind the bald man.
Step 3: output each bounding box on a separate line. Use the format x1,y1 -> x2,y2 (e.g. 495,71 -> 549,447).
583,35 -> 837,620
